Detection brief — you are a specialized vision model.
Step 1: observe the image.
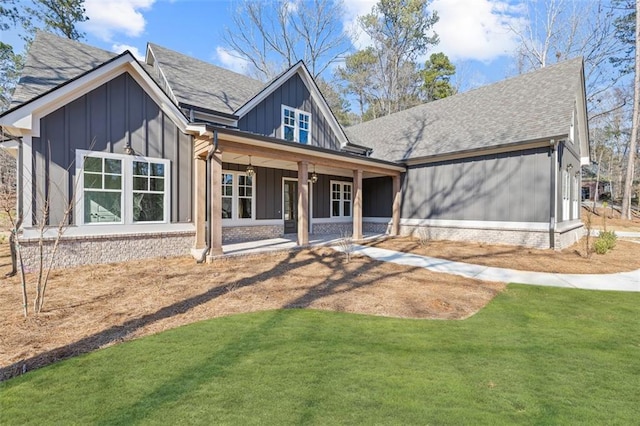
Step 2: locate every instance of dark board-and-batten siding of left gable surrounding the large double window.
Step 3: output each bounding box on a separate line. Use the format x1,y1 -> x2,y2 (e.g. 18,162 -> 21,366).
33,73 -> 193,224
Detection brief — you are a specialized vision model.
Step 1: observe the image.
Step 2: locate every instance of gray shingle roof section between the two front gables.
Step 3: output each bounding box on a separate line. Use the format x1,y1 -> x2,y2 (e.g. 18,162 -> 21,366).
149,43 -> 264,114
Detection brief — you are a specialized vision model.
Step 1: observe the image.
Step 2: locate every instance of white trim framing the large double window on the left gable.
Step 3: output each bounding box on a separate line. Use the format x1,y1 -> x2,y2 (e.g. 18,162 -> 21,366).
74,149 -> 171,226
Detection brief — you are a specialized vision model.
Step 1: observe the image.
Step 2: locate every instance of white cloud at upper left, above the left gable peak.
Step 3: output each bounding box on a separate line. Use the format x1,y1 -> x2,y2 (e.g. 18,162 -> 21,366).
82,0 -> 155,41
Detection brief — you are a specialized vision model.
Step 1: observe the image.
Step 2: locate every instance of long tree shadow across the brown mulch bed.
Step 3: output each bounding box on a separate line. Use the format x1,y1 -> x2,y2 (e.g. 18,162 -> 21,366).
0,250 -> 409,381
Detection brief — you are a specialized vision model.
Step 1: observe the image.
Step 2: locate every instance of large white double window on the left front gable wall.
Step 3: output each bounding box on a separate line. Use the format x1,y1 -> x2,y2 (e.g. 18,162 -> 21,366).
76,150 -> 169,224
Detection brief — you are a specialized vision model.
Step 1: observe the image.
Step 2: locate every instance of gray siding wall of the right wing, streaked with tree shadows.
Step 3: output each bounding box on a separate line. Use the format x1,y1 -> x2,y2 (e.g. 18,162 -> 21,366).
401,147 -> 551,222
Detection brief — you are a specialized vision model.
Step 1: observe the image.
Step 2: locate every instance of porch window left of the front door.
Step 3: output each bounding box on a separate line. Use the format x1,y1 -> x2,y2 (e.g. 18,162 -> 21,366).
222,172 -> 254,219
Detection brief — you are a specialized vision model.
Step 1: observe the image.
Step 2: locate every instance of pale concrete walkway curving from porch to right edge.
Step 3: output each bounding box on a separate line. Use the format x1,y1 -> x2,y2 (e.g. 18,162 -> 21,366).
333,244 -> 640,292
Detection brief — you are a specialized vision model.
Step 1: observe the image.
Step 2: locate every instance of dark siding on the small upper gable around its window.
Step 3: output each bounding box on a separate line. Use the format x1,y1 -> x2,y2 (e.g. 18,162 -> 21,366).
238,74 -> 340,151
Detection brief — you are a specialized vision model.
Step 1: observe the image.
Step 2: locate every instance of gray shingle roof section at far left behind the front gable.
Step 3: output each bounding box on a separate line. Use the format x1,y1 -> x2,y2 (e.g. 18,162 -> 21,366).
11,31 -> 117,107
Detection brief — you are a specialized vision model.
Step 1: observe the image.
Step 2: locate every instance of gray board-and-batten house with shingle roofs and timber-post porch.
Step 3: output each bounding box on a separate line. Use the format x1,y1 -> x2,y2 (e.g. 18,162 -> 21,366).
0,33 -> 588,265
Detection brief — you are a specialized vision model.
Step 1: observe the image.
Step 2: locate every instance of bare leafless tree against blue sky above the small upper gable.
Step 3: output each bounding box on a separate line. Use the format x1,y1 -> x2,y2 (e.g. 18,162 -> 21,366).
223,0 -> 351,80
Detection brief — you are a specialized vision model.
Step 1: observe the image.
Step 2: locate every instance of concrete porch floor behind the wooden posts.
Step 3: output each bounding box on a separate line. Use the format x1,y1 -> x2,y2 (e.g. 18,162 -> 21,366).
220,234 -> 387,257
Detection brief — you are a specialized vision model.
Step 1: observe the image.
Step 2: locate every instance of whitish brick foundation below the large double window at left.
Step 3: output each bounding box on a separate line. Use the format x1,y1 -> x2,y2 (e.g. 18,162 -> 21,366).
20,231 -> 195,271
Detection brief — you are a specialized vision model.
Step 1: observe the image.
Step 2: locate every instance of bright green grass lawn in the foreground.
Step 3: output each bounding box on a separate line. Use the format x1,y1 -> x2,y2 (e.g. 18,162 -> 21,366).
0,285 -> 640,425
